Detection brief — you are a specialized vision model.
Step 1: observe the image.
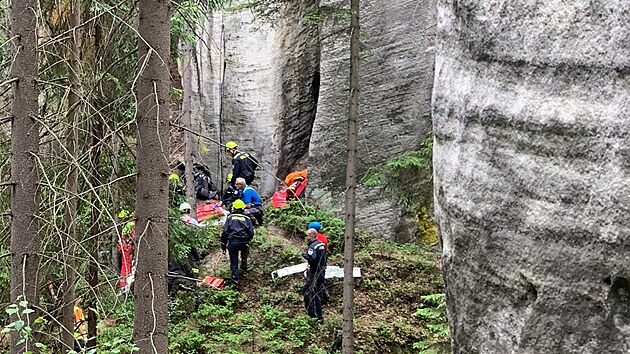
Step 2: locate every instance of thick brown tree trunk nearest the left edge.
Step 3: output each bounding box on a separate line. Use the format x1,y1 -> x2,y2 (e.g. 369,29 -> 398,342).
11,0 -> 39,353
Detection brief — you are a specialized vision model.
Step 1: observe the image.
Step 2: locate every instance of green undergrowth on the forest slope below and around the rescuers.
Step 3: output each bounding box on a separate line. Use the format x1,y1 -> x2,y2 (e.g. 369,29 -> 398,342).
101,205 -> 448,354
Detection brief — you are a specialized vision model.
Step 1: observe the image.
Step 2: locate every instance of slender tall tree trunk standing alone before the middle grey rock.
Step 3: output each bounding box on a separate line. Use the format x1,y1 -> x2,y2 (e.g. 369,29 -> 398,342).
342,0 -> 360,354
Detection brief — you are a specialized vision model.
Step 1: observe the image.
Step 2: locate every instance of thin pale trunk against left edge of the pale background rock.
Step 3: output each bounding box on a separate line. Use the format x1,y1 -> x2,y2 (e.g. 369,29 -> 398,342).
182,41 -> 197,218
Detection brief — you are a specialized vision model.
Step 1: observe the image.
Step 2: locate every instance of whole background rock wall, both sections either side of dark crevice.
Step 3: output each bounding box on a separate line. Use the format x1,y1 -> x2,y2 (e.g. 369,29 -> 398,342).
193,0 -> 435,239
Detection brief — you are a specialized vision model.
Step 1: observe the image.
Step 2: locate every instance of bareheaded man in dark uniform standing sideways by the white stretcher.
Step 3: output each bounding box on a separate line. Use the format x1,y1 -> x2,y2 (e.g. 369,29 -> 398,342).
302,228 -> 328,324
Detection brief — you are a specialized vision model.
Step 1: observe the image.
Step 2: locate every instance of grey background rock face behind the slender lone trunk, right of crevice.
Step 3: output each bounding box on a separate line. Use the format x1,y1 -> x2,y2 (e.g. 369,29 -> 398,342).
308,0 -> 435,238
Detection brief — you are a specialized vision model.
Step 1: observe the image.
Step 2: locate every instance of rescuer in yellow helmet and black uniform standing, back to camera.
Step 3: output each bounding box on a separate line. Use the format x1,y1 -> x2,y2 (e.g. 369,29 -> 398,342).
221,199 -> 254,286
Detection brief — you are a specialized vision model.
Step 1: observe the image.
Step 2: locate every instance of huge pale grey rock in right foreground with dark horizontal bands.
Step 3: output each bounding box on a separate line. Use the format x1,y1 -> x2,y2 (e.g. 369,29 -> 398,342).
433,0 -> 630,354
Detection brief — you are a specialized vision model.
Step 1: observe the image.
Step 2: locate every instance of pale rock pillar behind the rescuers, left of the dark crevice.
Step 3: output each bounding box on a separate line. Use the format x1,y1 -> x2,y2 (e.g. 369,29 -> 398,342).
193,0 -> 319,196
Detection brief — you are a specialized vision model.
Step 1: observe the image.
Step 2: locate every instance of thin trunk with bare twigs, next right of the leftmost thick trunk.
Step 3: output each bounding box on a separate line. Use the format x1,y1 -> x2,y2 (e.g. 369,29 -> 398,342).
61,0 -> 83,353
